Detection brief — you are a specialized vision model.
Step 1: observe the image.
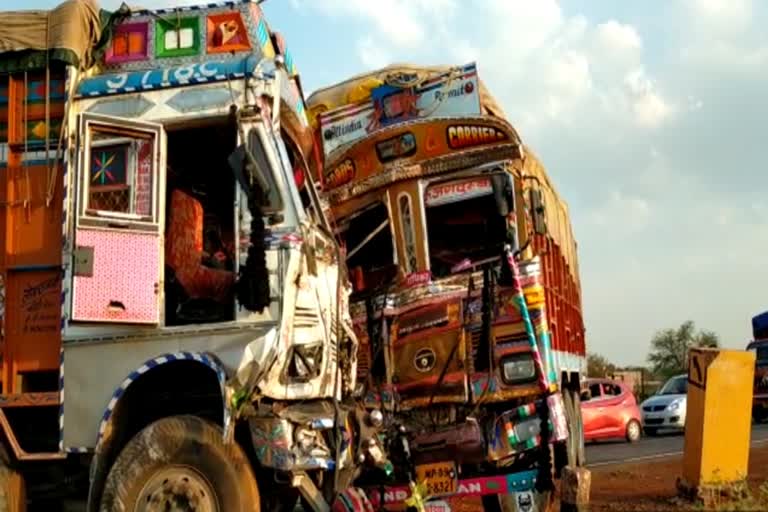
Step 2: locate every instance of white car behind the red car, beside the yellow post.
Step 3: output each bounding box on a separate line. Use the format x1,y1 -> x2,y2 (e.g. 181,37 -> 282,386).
640,375 -> 688,436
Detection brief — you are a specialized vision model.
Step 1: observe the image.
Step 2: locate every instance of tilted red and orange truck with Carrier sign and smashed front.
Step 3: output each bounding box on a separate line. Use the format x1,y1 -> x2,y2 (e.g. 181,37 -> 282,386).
307,64 -> 585,511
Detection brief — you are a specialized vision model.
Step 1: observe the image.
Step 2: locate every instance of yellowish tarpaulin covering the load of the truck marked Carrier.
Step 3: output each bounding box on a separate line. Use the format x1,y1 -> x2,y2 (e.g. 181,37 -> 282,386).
307,64 -> 580,284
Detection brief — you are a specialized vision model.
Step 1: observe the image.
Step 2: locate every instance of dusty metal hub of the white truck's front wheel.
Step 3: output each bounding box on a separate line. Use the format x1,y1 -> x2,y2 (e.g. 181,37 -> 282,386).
134,466 -> 219,512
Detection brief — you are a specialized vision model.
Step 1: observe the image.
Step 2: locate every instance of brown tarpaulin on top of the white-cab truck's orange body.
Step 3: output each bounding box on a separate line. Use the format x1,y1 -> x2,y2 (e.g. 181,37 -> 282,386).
0,0 -> 102,72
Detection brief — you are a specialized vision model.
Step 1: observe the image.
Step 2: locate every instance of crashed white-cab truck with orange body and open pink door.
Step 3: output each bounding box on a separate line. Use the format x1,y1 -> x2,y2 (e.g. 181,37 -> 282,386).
0,0 -> 388,512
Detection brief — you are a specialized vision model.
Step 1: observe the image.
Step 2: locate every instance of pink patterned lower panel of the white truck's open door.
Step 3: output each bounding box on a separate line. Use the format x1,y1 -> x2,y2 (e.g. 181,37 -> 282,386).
72,229 -> 161,324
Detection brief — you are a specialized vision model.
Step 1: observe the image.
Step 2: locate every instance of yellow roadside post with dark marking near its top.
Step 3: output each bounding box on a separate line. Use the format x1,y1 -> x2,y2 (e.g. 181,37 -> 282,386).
678,348 -> 755,503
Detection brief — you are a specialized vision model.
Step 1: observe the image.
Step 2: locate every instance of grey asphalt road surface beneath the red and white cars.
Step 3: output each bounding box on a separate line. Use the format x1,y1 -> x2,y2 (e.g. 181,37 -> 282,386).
587,424 -> 768,467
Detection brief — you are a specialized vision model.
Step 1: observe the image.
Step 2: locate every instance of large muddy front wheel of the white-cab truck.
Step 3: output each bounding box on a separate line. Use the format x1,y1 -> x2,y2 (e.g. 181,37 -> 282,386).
100,416 -> 261,512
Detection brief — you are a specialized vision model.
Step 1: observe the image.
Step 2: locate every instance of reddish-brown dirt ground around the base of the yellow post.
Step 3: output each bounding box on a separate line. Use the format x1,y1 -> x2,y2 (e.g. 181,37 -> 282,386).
572,446 -> 768,512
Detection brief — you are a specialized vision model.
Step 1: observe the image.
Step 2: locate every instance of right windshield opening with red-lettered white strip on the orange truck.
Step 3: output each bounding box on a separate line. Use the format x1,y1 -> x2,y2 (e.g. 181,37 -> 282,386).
424,177 -> 507,277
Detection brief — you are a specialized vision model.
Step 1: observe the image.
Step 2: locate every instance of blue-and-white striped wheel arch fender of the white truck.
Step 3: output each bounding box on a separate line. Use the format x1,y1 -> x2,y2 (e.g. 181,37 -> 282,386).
87,352 -> 231,512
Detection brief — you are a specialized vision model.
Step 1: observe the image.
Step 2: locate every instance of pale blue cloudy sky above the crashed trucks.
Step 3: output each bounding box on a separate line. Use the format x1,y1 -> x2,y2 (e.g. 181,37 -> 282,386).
10,0 -> 768,365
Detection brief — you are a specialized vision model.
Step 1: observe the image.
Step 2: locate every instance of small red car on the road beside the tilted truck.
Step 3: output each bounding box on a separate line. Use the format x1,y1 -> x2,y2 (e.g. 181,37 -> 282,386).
581,379 -> 642,443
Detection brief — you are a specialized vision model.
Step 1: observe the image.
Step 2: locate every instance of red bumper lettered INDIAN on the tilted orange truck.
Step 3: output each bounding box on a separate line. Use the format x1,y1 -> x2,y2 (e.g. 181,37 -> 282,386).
366,470 -> 538,512
